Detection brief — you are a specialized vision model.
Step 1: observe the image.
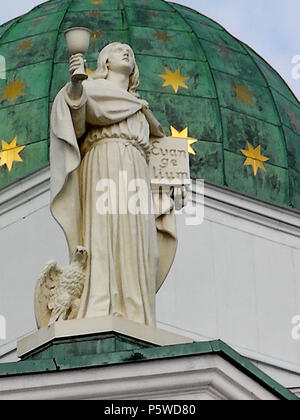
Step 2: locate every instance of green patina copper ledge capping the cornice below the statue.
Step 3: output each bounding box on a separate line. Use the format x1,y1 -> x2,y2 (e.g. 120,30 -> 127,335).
0,332 -> 299,400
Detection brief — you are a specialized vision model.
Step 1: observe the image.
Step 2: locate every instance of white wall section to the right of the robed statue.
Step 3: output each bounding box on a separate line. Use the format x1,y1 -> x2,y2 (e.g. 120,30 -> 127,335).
157,186 -> 300,386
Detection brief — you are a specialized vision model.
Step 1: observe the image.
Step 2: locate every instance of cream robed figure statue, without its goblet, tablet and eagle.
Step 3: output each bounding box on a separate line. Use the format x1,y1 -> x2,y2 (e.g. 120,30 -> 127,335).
50,43 -> 177,326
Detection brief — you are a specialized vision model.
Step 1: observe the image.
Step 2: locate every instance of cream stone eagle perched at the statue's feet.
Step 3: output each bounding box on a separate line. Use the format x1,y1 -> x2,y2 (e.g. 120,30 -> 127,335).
35,246 -> 88,328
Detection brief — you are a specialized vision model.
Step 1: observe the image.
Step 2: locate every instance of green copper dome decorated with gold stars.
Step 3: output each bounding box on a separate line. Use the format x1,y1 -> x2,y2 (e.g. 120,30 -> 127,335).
0,0 -> 300,210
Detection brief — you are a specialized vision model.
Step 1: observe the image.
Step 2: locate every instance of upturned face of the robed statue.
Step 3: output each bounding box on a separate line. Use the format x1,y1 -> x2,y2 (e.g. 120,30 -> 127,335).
108,44 -> 135,75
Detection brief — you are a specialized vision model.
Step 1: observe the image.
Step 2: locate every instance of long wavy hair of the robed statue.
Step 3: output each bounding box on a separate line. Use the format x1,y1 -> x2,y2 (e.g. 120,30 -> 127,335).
90,42 -> 140,97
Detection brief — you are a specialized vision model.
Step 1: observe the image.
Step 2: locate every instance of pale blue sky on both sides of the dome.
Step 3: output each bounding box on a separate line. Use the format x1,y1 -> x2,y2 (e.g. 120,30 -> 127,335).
0,0 -> 300,100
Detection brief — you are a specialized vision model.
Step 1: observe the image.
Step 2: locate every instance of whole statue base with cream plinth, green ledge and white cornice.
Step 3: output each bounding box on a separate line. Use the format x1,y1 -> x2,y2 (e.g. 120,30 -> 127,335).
0,317 -> 292,401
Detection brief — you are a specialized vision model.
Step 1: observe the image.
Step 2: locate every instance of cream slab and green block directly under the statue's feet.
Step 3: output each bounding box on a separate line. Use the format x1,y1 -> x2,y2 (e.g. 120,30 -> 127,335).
18,317 -> 193,360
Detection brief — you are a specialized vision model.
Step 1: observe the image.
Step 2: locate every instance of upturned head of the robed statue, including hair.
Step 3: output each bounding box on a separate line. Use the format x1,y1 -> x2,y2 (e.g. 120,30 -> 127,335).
92,42 -> 140,96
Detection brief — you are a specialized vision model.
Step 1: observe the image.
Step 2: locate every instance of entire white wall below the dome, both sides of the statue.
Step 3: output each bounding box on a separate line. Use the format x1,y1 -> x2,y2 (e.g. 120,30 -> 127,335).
0,170 -> 300,388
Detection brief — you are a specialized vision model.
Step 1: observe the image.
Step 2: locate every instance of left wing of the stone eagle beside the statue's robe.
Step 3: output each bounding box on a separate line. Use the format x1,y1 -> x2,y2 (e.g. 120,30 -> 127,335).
34,261 -> 63,328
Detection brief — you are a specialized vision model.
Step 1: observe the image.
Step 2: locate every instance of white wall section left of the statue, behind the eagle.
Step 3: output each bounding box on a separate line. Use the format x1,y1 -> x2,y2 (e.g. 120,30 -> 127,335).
0,169 -> 68,361
